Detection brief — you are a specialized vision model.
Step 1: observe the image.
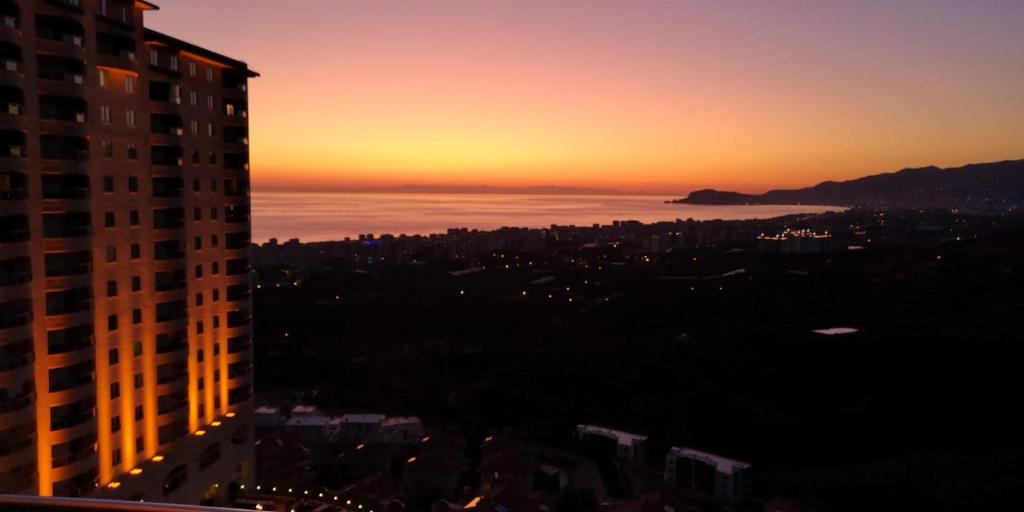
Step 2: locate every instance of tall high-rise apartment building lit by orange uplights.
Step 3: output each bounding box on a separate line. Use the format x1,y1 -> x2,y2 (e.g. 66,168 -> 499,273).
0,0 -> 256,503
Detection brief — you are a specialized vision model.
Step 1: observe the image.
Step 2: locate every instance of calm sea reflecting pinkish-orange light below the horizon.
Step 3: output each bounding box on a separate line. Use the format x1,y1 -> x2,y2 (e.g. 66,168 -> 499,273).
252,193 -> 836,243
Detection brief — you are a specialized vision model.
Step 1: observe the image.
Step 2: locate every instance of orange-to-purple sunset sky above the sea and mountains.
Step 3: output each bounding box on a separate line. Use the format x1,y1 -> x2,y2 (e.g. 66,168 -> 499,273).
146,0 -> 1024,194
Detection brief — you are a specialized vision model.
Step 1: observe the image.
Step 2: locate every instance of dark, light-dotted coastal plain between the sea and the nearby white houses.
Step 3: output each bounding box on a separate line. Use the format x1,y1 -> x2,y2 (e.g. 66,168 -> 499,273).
249,211 -> 1024,510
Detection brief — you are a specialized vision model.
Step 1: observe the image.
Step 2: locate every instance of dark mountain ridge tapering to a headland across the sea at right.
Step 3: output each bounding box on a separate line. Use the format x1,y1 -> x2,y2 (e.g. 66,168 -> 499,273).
671,160 -> 1024,210
